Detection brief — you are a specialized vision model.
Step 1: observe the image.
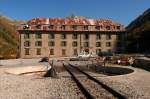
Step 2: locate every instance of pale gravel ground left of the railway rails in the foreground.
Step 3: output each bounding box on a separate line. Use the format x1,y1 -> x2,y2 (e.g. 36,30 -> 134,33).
0,68 -> 84,99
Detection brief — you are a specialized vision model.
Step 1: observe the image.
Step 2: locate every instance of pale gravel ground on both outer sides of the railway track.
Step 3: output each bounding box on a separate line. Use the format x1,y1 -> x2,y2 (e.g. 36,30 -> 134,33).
0,60 -> 150,99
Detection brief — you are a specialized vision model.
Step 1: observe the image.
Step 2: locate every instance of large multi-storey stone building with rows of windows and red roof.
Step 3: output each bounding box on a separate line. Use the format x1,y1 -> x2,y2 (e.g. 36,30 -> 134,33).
18,17 -> 125,58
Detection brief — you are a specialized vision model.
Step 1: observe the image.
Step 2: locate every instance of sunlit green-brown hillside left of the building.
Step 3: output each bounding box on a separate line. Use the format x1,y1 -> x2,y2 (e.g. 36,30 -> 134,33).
0,16 -> 19,59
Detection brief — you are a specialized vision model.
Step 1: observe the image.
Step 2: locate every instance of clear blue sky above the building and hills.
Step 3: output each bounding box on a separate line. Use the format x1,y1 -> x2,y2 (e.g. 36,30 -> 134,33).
0,0 -> 150,26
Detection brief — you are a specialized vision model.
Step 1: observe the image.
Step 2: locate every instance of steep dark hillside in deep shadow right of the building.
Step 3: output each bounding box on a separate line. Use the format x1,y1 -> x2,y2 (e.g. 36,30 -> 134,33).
126,8 -> 150,53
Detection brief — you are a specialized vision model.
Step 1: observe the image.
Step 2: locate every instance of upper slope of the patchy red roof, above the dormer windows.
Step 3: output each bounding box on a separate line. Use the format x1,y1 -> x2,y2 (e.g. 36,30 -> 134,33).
27,17 -> 120,25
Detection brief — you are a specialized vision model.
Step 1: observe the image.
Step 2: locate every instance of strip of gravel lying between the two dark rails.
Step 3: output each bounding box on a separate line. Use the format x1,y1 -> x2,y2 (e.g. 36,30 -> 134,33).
67,66 -> 116,99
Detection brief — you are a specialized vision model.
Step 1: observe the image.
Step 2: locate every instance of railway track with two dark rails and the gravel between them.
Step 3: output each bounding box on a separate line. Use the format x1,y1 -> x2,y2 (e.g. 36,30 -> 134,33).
63,64 -> 126,99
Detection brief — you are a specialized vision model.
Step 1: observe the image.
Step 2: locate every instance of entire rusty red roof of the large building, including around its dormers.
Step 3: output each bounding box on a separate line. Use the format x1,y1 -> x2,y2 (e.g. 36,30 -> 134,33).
18,17 -> 125,31
